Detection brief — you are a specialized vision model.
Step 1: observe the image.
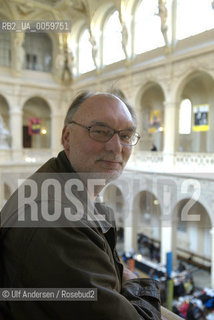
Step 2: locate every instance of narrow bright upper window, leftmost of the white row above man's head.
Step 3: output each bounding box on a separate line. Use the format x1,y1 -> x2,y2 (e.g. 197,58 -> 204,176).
79,29 -> 95,73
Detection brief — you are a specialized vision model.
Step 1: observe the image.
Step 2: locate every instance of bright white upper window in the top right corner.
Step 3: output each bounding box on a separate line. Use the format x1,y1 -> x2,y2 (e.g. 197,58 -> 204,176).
177,0 -> 214,40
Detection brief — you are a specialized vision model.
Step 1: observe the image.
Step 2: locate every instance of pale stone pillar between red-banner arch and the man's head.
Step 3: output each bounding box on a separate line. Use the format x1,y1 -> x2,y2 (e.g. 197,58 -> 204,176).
51,112 -> 64,156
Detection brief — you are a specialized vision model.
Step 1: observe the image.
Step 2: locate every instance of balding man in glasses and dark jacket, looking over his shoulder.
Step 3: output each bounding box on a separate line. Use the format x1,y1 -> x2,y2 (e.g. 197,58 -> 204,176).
1,92 -> 160,320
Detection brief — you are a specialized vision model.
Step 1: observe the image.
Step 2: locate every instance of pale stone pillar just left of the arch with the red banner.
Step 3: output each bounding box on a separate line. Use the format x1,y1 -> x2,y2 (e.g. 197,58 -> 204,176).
10,106 -> 23,161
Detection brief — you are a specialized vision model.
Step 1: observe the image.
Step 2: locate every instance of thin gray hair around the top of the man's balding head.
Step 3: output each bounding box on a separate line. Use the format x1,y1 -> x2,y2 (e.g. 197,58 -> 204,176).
64,89 -> 137,126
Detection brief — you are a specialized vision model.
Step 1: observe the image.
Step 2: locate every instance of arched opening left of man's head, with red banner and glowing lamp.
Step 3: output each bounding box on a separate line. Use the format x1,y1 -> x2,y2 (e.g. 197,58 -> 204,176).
23,97 -> 51,149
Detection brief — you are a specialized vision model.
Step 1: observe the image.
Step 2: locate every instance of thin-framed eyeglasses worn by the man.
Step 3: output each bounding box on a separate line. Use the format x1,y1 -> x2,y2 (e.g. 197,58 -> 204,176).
69,121 -> 140,146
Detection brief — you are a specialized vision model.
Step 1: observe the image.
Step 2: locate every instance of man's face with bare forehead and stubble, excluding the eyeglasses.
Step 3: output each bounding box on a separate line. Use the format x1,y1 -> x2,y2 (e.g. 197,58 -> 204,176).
62,94 -> 135,182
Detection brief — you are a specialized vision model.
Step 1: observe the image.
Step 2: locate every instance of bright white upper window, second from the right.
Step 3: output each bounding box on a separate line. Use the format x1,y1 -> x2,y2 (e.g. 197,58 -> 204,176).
134,0 -> 164,54
